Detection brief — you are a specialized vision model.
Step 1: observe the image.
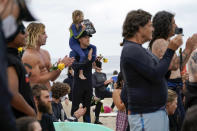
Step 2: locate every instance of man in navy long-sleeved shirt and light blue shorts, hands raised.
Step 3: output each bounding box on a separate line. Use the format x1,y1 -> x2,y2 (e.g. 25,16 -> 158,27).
120,10 -> 182,131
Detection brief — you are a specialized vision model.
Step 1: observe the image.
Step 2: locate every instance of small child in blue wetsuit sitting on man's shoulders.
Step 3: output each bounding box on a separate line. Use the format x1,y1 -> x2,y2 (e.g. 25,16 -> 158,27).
69,10 -> 96,80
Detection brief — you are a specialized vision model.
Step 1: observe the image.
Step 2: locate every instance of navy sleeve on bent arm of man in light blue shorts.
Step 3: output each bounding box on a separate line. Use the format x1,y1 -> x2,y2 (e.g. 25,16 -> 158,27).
125,48 -> 175,82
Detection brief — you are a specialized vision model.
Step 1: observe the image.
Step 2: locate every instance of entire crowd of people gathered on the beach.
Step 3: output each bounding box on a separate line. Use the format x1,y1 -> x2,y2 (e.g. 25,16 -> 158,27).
0,0 -> 197,131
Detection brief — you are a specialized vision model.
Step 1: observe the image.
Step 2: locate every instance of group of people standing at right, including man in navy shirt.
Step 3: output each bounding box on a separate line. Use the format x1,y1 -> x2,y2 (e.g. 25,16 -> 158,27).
120,9 -> 197,131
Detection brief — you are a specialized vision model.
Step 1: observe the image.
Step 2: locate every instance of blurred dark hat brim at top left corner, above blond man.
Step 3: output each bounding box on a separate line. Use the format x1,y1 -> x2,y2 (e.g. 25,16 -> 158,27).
17,0 -> 36,21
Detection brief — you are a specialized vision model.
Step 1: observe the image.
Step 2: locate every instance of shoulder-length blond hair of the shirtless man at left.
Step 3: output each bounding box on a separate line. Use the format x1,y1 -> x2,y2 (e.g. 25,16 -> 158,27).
26,23 -> 45,48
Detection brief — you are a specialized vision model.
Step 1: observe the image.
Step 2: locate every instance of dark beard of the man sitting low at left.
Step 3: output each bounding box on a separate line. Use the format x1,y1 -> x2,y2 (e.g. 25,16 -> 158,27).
38,100 -> 52,114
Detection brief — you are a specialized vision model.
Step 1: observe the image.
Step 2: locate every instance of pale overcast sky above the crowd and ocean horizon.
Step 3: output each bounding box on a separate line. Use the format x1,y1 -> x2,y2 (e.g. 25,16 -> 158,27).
25,0 -> 197,58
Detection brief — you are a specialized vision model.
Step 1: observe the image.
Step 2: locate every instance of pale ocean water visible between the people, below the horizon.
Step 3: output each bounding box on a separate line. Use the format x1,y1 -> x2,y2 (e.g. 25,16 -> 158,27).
52,56 -> 120,82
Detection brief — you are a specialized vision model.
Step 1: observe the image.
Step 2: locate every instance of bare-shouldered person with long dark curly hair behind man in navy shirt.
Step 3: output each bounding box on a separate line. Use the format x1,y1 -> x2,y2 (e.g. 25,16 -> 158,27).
149,11 -> 197,130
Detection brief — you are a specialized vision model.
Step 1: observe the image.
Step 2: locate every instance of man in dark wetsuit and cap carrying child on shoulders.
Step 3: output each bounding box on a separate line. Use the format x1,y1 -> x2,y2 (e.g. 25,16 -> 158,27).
70,31 -> 96,122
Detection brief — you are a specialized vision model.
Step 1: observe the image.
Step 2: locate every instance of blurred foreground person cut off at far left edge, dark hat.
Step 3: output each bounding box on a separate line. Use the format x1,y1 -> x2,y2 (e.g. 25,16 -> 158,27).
0,0 -> 35,131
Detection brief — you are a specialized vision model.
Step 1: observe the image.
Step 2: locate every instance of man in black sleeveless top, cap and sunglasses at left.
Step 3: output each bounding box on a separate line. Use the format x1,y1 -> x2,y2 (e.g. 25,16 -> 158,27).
7,24 -> 36,118
